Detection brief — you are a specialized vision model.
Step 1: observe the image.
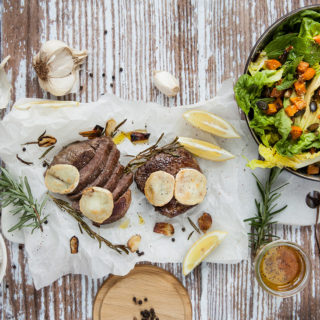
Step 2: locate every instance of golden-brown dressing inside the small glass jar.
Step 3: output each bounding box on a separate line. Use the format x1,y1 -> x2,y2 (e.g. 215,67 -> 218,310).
260,245 -> 306,291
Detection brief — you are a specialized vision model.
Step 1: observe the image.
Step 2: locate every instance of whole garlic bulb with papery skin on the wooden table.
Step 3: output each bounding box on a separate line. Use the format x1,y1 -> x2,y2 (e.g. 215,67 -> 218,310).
33,40 -> 87,96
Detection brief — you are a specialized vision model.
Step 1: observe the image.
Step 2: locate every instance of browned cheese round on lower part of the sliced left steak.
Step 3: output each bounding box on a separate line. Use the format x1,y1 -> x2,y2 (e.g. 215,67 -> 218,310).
79,187 -> 114,223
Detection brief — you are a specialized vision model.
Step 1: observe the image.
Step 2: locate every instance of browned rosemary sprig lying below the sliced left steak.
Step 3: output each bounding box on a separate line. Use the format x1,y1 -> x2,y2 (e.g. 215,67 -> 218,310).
49,195 -> 129,254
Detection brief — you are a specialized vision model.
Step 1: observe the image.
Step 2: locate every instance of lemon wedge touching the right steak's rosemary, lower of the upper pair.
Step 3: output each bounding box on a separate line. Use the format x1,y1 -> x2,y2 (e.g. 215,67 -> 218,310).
178,137 -> 234,161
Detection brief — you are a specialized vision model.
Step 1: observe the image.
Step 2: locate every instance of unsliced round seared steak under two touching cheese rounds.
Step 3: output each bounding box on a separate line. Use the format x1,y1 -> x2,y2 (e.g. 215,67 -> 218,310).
134,148 -> 201,218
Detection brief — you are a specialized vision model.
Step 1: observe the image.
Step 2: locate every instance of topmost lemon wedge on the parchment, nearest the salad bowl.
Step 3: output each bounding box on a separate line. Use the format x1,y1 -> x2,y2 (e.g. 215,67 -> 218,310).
183,110 -> 240,138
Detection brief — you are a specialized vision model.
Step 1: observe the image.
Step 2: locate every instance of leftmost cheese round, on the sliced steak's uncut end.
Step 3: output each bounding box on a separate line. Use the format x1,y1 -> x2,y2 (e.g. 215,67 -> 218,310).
44,164 -> 80,194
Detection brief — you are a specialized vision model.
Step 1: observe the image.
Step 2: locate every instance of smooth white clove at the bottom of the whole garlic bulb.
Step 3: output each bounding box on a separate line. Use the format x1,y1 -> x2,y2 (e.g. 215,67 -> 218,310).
39,71 -> 77,97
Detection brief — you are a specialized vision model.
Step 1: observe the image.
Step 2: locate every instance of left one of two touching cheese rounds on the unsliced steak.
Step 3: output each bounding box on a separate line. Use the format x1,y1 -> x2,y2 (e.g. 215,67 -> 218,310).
144,170 -> 175,207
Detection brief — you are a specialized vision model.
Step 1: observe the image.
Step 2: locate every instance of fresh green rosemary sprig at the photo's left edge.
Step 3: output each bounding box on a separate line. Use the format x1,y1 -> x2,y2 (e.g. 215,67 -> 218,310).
0,168 -> 47,232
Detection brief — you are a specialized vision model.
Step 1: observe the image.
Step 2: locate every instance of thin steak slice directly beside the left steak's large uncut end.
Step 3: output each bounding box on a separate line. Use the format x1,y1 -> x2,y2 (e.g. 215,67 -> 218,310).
72,137 -> 113,194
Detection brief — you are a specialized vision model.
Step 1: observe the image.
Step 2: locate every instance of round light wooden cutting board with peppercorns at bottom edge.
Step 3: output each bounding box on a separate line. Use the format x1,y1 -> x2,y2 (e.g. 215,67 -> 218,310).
93,265 -> 192,320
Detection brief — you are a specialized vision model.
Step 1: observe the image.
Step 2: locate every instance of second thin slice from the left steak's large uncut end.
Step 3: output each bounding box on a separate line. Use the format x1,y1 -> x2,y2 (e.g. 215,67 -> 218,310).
69,143 -> 120,200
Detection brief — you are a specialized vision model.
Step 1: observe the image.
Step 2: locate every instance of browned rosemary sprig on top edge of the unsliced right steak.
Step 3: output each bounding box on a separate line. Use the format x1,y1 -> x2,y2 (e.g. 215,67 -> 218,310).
125,133 -> 182,172
